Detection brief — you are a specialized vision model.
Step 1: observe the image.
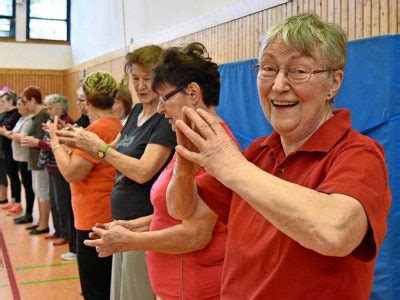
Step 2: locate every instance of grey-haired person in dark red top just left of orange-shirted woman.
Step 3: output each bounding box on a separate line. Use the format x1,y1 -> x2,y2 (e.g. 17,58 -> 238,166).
38,94 -> 73,246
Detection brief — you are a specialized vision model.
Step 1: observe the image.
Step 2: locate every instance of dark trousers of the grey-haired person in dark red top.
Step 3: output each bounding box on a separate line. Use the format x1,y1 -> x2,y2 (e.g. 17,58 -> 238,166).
49,173 -> 71,239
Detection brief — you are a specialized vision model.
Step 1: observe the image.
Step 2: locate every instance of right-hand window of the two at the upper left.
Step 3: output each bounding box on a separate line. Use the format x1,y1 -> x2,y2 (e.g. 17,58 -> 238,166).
27,0 -> 70,41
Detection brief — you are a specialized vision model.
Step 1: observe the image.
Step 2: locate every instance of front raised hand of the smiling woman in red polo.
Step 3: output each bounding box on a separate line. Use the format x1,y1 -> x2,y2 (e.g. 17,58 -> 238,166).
175,107 -> 246,179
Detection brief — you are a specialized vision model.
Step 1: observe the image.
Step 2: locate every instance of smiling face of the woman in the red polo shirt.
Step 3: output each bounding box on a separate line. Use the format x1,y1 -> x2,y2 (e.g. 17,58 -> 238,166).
257,39 -> 343,143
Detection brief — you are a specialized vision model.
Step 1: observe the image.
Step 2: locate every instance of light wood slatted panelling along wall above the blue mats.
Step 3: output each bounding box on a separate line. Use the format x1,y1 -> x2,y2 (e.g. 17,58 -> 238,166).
5,0 -> 400,115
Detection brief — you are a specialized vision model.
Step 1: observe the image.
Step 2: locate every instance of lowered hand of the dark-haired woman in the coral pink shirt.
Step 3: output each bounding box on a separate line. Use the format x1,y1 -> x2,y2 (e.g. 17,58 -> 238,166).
83,222 -> 135,257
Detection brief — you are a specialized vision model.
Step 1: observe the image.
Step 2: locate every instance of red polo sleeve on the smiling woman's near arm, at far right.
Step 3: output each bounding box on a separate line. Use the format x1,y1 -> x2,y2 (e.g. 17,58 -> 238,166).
317,145 -> 391,260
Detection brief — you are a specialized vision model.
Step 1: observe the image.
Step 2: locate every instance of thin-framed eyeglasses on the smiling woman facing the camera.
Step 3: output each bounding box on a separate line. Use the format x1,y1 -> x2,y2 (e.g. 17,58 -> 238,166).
254,64 -> 336,84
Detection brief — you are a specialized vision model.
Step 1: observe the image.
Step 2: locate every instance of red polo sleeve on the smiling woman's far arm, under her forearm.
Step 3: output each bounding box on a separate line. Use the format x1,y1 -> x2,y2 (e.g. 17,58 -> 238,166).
196,173 -> 232,224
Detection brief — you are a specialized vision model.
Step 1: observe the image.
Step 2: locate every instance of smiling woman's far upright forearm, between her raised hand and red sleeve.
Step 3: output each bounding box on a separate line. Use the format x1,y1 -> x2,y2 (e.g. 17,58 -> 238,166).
167,170 -> 199,220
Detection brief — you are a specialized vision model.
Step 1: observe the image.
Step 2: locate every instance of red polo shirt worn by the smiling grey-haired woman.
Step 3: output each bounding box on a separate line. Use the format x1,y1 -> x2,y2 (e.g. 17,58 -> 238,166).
197,110 -> 391,299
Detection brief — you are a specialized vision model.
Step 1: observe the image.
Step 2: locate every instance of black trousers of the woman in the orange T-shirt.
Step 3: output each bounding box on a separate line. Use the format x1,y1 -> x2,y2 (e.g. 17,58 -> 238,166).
76,229 -> 112,300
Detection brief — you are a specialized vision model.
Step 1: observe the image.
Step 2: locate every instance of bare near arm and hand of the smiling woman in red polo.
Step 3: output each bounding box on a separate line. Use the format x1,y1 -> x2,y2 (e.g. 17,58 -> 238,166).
176,108 -> 368,256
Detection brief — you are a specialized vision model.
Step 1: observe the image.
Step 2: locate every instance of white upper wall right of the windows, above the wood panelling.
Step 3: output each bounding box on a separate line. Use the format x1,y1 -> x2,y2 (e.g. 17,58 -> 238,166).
71,0 -> 287,65
